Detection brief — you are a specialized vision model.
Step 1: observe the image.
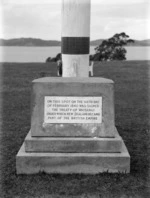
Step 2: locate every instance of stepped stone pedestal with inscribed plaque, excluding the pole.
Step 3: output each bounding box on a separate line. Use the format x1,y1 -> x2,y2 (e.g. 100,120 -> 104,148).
16,77 -> 130,174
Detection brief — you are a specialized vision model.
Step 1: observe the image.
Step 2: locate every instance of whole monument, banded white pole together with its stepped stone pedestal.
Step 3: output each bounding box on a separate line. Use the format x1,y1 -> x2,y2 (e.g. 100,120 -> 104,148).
16,0 -> 130,174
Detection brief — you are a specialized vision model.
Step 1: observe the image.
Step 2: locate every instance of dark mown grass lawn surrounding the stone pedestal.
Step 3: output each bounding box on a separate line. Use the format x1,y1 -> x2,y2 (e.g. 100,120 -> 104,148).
0,61 -> 150,198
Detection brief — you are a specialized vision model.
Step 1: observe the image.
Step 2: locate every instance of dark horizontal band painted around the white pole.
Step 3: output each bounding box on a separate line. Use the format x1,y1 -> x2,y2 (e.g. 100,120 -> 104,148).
61,37 -> 90,54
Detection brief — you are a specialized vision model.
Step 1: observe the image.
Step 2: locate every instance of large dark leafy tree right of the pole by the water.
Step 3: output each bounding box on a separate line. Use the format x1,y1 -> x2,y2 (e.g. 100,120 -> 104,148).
92,32 -> 134,61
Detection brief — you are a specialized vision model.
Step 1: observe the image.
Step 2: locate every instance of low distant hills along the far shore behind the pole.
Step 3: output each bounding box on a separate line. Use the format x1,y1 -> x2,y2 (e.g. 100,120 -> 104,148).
0,38 -> 150,47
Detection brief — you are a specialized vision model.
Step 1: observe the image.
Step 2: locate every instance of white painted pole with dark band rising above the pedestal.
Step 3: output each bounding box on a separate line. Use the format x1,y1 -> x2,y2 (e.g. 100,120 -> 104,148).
61,0 -> 91,77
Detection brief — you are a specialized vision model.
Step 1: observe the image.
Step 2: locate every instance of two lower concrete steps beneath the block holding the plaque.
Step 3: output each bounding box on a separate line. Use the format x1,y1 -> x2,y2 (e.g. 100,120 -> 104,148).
16,128 -> 130,174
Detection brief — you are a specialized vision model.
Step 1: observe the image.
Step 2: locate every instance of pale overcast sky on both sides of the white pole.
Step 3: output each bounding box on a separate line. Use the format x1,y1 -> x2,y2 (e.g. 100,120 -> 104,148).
0,0 -> 150,40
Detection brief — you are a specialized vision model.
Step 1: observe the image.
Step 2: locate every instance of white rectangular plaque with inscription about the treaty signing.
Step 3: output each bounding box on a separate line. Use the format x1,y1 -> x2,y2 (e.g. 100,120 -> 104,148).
44,96 -> 102,124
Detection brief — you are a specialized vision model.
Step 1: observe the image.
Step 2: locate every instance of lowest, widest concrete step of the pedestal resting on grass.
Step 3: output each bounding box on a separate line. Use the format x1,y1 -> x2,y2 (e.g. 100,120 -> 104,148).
16,142 -> 130,174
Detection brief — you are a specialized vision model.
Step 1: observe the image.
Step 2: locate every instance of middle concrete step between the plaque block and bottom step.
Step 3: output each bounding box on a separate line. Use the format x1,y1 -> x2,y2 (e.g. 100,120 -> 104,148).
25,128 -> 122,153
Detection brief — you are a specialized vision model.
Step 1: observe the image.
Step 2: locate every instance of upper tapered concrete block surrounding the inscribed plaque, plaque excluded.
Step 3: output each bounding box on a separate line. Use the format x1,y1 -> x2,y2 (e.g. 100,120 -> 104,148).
31,77 -> 115,137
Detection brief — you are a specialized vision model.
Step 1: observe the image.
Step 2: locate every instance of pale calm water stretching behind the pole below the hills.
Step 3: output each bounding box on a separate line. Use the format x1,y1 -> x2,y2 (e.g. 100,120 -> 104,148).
0,46 -> 150,62
